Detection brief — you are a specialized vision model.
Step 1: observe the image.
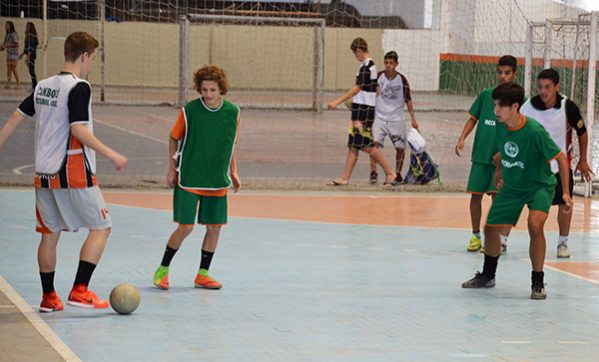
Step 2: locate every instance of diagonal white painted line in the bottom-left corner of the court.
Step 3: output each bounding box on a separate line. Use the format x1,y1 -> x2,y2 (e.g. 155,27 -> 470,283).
0,276 -> 81,362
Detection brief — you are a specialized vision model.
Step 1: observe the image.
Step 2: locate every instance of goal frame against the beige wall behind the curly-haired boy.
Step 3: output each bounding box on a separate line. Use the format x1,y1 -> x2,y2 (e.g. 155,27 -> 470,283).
178,14 -> 325,111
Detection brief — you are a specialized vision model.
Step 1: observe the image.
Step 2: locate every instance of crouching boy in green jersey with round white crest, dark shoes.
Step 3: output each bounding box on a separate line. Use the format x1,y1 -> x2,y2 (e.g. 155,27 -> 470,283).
462,83 -> 572,299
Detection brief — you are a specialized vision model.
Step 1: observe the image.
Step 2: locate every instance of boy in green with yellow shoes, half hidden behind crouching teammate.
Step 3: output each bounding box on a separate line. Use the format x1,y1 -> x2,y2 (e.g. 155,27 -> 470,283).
455,55 -> 518,252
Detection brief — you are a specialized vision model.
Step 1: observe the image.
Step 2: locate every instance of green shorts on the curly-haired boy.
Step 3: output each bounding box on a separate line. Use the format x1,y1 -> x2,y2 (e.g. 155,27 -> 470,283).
173,185 -> 227,225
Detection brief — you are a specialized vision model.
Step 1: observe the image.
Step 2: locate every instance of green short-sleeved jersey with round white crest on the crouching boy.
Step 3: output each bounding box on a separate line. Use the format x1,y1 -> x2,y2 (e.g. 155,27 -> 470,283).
497,115 -> 561,192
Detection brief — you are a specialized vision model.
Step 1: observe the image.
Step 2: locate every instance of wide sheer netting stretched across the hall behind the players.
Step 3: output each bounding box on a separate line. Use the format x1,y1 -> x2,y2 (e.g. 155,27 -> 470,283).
0,0 -> 599,191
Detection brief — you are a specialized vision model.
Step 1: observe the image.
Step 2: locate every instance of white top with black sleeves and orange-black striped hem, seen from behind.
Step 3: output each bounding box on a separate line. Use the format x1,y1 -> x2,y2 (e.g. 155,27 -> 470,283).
18,72 -> 97,189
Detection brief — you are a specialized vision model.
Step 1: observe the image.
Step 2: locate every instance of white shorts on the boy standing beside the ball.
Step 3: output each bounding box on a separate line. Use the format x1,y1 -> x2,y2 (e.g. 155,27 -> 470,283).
35,186 -> 112,234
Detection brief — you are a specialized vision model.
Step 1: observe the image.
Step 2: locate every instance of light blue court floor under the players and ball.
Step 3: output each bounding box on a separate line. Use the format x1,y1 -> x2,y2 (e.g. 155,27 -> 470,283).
0,190 -> 599,361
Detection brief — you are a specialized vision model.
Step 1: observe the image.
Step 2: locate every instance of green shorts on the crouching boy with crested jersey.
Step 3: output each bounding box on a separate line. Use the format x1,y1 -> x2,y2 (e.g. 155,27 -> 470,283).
487,187 -> 555,225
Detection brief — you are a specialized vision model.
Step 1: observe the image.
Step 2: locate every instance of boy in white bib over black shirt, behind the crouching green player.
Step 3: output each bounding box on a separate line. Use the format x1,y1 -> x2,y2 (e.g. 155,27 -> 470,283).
521,69 -> 592,258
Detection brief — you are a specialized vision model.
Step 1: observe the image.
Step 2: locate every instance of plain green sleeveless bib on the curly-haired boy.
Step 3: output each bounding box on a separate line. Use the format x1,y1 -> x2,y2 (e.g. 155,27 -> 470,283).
179,98 -> 239,190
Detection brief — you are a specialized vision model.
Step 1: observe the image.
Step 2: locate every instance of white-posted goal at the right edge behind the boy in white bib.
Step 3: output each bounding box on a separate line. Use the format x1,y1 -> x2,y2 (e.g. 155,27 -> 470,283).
524,12 -> 599,197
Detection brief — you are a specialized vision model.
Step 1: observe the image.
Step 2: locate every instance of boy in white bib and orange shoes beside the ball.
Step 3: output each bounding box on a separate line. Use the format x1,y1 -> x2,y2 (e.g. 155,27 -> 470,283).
0,32 -> 127,312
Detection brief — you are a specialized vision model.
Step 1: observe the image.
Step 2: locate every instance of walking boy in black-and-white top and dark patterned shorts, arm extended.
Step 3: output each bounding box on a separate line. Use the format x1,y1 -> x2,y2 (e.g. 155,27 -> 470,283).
328,38 -> 396,186
